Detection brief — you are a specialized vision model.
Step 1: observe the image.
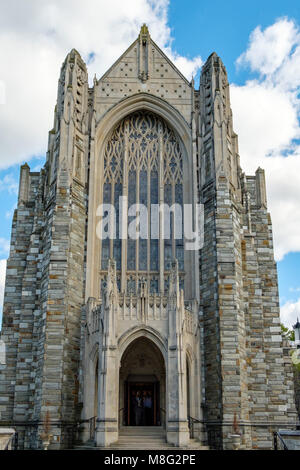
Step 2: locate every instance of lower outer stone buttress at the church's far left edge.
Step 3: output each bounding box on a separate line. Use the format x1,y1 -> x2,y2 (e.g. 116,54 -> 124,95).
0,165 -> 44,445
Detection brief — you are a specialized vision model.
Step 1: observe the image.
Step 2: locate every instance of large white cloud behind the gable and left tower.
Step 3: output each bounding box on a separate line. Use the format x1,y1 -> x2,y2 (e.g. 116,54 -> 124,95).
0,0 -> 202,168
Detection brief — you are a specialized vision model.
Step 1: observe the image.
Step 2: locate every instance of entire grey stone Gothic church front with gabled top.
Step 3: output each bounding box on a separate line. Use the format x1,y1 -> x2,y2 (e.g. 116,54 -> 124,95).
0,27 -> 296,449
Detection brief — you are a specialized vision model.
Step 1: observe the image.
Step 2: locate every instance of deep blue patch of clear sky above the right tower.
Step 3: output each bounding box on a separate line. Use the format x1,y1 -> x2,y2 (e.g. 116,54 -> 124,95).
169,0 -> 300,79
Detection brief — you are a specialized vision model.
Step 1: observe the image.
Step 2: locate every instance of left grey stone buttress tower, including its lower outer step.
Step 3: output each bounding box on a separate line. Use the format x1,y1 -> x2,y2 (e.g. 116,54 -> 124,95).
0,51 -> 88,448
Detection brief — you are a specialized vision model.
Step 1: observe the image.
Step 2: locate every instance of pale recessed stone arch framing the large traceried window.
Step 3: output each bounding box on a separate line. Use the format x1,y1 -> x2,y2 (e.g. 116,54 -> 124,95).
86,93 -> 196,299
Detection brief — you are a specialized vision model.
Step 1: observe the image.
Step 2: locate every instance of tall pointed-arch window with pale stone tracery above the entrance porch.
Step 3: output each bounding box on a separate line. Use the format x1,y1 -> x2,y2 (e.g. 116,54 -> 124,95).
101,111 -> 184,293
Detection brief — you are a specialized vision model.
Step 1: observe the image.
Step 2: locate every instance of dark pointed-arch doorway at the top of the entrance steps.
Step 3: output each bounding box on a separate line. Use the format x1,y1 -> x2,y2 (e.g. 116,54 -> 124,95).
119,337 -> 166,428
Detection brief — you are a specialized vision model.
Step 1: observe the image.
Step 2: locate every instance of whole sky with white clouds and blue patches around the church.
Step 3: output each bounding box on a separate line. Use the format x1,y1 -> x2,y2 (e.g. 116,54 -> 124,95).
0,0 -> 300,325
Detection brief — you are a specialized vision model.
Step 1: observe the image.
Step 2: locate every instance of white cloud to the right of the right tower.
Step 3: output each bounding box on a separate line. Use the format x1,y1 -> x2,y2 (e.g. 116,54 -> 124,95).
231,18 -> 300,260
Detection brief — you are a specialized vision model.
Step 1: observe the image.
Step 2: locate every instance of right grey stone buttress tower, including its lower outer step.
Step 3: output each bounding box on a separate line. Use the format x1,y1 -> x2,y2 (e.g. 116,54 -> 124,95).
198,54 -> 296,449
